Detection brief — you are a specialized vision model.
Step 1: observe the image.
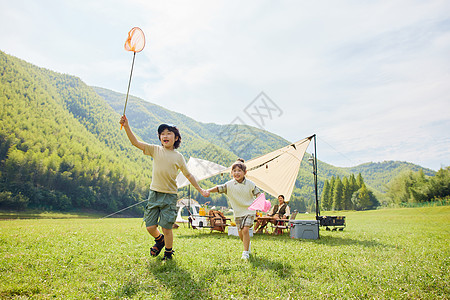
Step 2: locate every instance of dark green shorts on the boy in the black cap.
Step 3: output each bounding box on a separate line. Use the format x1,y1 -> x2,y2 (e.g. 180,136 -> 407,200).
144,190 -> 178,229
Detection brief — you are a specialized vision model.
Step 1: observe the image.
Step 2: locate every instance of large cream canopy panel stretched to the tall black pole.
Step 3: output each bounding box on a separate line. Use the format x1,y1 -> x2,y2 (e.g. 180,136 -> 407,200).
222,136 -> 314,200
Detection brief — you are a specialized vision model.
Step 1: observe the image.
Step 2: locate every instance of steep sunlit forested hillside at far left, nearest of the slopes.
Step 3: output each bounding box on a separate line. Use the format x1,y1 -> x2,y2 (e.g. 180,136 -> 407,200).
0,52 -> 151,211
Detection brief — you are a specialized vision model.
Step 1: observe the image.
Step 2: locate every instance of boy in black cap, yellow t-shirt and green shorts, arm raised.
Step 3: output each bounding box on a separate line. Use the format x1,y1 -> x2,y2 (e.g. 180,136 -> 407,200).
120,115 -> 209,260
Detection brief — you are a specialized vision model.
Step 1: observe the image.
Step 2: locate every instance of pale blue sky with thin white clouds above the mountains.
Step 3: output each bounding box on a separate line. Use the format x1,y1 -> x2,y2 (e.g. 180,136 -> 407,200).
0,0 -> 450,170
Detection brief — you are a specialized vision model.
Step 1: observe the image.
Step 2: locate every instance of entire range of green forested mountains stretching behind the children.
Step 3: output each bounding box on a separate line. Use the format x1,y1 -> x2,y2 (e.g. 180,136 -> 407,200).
0,51 -> 434,214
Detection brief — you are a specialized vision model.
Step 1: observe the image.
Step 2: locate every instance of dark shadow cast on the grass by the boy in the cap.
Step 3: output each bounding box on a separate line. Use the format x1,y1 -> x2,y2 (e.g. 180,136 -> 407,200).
149,260 -> 212,300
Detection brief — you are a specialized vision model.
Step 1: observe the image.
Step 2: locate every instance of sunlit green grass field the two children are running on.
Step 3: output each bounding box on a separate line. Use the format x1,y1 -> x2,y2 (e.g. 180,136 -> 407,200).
0,206 -> 450,299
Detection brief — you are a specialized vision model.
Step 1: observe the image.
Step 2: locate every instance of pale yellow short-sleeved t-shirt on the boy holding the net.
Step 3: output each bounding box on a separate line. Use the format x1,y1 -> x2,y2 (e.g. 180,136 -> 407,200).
144,144 -> 190,194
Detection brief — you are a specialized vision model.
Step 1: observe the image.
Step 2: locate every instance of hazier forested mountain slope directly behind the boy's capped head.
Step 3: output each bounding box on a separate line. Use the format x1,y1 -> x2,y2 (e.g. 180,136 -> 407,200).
93,87 -> 289,165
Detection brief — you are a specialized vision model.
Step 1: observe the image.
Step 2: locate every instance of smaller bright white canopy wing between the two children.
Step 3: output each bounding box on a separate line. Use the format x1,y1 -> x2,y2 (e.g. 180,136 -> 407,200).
177,156 -> 226,188
